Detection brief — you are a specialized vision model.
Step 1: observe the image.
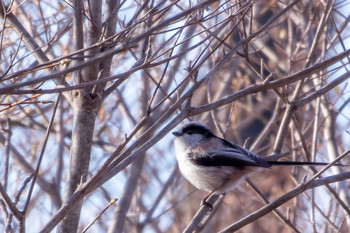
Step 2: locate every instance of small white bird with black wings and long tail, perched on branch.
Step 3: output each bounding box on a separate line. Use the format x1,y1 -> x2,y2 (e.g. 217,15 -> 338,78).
173,123 -> 336,209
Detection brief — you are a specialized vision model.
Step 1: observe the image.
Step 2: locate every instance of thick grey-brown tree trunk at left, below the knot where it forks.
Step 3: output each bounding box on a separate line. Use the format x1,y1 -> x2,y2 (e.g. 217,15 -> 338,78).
57,91 -> 100,233
